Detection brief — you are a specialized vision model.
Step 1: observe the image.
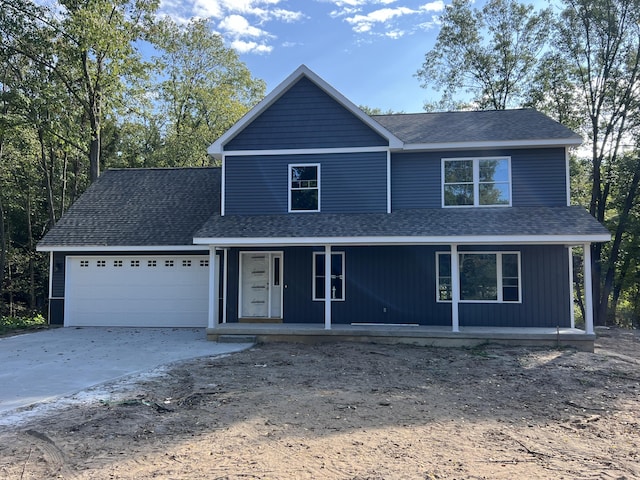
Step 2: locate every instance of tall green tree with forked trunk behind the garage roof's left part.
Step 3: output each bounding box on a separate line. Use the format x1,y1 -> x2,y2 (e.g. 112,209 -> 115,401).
0,0 -> 158,181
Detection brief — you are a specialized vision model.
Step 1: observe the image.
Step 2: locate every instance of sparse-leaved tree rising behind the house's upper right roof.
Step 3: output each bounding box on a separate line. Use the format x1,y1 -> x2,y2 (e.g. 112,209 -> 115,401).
417,0 -> 551,110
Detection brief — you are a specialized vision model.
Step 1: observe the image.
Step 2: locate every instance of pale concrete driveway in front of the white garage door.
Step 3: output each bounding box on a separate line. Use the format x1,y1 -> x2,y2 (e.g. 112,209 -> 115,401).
0,327 -> 251,414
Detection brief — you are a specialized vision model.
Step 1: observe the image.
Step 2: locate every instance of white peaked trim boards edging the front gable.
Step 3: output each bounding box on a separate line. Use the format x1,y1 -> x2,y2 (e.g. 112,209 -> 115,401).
207,65 -> 403,158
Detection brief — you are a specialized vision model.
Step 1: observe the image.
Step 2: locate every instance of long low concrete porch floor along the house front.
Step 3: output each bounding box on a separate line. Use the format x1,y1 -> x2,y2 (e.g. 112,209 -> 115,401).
207,323 -> 596,352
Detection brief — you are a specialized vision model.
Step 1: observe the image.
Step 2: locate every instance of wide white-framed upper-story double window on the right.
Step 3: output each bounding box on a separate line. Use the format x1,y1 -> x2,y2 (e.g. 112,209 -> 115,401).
442,157 -> 511,207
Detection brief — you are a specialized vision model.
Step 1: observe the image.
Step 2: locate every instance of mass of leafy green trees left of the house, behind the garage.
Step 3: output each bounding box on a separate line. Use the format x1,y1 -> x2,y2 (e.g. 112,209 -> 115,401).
0,0 -> 265,318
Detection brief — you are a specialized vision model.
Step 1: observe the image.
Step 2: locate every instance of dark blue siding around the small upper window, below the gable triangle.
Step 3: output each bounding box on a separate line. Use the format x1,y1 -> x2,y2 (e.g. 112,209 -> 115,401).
225,152 -> 387,215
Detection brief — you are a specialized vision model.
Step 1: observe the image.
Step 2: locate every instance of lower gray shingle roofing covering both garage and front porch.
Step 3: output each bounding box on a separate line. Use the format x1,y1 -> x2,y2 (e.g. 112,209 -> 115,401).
39,168 -> 608,249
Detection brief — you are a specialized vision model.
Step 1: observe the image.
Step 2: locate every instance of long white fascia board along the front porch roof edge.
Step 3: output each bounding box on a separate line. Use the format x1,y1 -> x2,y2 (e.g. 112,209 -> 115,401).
193,234 -> 611,247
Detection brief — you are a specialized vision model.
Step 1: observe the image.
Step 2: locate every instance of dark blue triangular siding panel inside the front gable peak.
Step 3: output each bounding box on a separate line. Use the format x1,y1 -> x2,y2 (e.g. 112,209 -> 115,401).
224,77 -> 389,151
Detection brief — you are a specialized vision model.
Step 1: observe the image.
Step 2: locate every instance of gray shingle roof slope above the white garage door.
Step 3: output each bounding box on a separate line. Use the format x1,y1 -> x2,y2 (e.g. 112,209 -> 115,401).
38,168 -> 220,249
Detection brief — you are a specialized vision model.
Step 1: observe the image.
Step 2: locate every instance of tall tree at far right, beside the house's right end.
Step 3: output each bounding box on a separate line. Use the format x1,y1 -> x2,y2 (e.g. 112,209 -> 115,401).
555,0 -> 640,324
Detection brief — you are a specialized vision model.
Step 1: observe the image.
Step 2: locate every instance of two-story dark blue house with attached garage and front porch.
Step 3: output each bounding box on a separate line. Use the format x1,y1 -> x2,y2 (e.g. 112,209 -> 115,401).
38,66 -> 610,348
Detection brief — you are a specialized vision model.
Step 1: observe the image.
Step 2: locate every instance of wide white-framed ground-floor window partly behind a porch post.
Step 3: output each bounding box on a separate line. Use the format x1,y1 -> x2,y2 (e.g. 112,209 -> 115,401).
436,252 -> 521,302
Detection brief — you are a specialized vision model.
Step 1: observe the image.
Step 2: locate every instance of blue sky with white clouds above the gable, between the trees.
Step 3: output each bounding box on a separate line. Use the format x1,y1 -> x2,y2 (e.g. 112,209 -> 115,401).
161,0 -> 445,113
